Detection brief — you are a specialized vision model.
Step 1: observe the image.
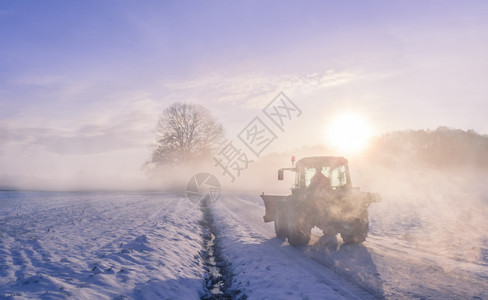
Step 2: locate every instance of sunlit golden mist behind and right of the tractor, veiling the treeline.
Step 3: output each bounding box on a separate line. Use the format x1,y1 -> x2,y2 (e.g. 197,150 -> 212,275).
217,127 -> 488,268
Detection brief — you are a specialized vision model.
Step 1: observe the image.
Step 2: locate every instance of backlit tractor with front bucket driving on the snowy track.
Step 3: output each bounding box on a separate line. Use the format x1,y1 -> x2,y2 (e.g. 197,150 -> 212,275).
261,156 -> 381,246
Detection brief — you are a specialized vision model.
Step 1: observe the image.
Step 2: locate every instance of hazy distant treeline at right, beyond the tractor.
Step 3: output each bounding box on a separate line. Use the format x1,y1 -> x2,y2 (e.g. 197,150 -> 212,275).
370,127 -> 488,169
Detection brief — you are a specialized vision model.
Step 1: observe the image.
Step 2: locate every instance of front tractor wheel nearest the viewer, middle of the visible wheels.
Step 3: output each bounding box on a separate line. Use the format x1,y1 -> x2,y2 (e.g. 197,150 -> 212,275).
287,205 -> 311,246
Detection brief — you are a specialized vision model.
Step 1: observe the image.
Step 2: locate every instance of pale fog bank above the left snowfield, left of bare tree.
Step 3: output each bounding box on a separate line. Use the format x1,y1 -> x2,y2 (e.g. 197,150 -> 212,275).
0,93 -> 159,189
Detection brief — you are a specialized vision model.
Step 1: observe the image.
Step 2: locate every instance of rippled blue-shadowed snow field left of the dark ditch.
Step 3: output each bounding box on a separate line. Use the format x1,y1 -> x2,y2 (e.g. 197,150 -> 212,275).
0,192 -> 205,299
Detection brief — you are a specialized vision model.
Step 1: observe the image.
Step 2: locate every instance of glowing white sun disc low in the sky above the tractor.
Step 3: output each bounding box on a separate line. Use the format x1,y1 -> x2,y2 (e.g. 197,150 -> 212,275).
326,112 -> 372,153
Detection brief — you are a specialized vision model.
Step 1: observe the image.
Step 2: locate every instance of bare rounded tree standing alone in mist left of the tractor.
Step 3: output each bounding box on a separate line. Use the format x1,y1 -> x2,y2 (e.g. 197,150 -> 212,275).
146,102 -> 224,168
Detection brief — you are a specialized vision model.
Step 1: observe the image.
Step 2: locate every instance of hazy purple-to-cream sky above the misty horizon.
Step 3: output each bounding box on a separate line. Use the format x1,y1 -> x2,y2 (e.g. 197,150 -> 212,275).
0,0 -> 488,188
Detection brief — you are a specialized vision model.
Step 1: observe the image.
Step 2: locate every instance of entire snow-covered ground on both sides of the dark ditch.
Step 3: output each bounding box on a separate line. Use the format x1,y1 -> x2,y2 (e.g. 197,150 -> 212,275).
0,192 -> 488,299
